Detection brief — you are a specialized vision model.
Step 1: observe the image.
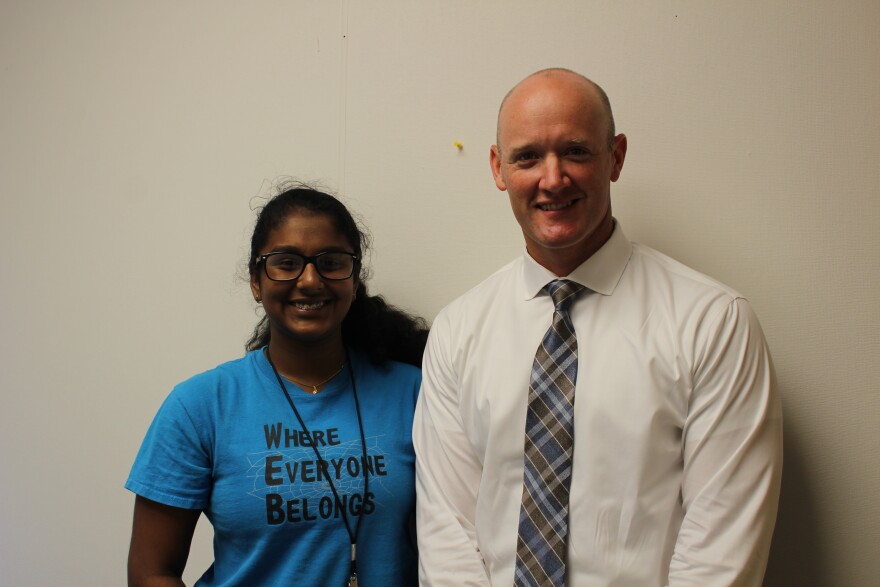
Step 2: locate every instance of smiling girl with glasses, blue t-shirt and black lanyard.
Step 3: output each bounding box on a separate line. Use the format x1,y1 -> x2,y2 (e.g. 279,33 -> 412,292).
126,185 -> 427,587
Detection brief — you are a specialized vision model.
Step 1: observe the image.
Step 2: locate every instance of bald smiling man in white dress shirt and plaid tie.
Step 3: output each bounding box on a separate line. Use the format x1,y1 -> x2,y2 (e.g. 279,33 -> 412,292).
413,69 -> 782,587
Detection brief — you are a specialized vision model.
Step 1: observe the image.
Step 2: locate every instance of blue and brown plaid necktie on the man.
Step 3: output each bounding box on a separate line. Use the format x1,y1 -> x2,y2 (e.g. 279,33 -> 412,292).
514,279 -> 584,587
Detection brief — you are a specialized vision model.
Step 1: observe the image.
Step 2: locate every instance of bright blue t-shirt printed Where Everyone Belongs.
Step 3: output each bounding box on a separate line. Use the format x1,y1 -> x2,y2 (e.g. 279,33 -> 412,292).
125,351 -> 421,587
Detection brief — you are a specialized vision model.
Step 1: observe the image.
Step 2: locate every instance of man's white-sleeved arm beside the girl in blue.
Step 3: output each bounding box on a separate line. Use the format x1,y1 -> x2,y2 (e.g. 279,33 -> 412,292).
413,316 -> 489,587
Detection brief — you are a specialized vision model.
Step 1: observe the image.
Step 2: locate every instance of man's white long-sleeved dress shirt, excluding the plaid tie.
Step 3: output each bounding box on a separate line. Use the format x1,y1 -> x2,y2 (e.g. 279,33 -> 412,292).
413,225 -> 782,587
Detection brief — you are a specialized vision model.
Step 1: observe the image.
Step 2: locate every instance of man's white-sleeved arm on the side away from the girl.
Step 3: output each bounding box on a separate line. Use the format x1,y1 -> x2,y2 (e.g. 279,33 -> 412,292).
669,299 -> 782,587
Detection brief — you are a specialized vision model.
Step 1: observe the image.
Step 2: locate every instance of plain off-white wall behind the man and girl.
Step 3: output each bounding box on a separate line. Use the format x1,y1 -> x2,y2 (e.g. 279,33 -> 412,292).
0,0 -> 880,586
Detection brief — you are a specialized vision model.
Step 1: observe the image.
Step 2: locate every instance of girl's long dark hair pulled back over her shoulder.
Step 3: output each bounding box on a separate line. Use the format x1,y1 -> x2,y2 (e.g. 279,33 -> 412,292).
245,182 -> 428,366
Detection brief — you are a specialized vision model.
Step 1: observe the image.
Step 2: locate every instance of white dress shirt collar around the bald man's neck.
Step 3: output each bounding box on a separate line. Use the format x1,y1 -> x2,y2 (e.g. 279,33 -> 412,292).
522,219 -> 632,300
